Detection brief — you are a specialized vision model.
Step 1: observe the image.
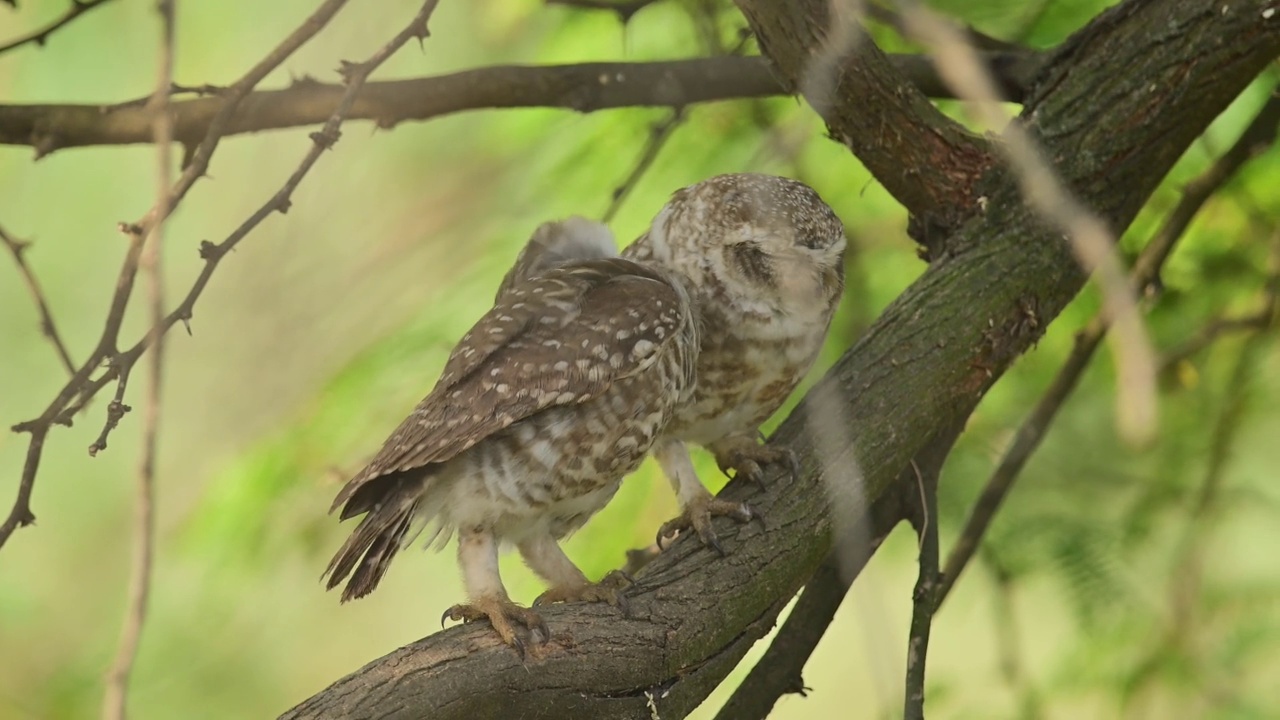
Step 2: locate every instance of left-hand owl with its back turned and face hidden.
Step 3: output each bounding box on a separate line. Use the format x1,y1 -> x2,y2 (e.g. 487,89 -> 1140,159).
325,218 -> 699,656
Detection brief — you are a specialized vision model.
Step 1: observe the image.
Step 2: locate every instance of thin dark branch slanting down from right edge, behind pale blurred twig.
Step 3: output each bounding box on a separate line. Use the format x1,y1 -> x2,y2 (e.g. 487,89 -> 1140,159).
938,90 -> 1280,605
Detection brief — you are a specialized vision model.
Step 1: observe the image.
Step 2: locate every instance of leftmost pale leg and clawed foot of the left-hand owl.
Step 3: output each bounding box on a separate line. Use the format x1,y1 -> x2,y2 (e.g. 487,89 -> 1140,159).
442,520 -> 550,659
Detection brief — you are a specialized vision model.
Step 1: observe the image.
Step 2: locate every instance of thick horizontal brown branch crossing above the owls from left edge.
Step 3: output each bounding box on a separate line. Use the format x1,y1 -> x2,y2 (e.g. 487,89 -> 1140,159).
0,53 -> 1041,156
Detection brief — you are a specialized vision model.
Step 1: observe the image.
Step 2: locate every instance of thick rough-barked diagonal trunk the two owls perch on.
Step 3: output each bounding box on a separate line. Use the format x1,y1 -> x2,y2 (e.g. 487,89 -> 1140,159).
284,0 -> 1280,719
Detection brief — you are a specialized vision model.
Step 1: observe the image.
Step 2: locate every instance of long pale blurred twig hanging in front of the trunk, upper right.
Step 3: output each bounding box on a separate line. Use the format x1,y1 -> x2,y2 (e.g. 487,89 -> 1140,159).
902,0 -> 1156,445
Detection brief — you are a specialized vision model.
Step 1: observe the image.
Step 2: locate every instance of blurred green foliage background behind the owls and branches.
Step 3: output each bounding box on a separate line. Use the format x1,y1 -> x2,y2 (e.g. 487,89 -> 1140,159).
0,0 -> 1280,719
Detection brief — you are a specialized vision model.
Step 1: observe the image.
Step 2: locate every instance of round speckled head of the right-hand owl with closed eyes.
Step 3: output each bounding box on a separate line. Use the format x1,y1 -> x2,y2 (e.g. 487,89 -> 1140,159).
646,173 -> 845,315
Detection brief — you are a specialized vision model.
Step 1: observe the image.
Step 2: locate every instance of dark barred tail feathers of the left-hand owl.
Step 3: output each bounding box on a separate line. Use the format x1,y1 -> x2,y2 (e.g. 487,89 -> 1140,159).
321,482 -> 422,602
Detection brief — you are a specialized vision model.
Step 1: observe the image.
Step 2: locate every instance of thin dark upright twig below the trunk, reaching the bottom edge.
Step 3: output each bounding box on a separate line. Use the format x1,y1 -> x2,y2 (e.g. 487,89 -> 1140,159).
902,456 -> 938,720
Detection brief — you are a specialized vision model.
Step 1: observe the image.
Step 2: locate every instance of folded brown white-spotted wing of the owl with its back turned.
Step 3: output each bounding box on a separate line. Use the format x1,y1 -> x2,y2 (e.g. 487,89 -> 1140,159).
333,258 -> 694,509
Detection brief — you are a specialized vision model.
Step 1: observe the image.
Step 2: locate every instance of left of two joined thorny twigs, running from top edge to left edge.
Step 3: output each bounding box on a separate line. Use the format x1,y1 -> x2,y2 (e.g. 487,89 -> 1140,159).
0,0 -> 346,547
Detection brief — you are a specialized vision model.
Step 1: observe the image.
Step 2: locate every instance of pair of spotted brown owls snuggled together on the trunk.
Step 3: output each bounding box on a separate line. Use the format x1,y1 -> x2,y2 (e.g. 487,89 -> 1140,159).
318,174 -> 845,655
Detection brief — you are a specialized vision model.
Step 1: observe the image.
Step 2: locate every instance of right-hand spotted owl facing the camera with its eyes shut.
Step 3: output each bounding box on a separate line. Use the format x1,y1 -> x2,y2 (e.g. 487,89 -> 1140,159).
622,173 -> 845,555
